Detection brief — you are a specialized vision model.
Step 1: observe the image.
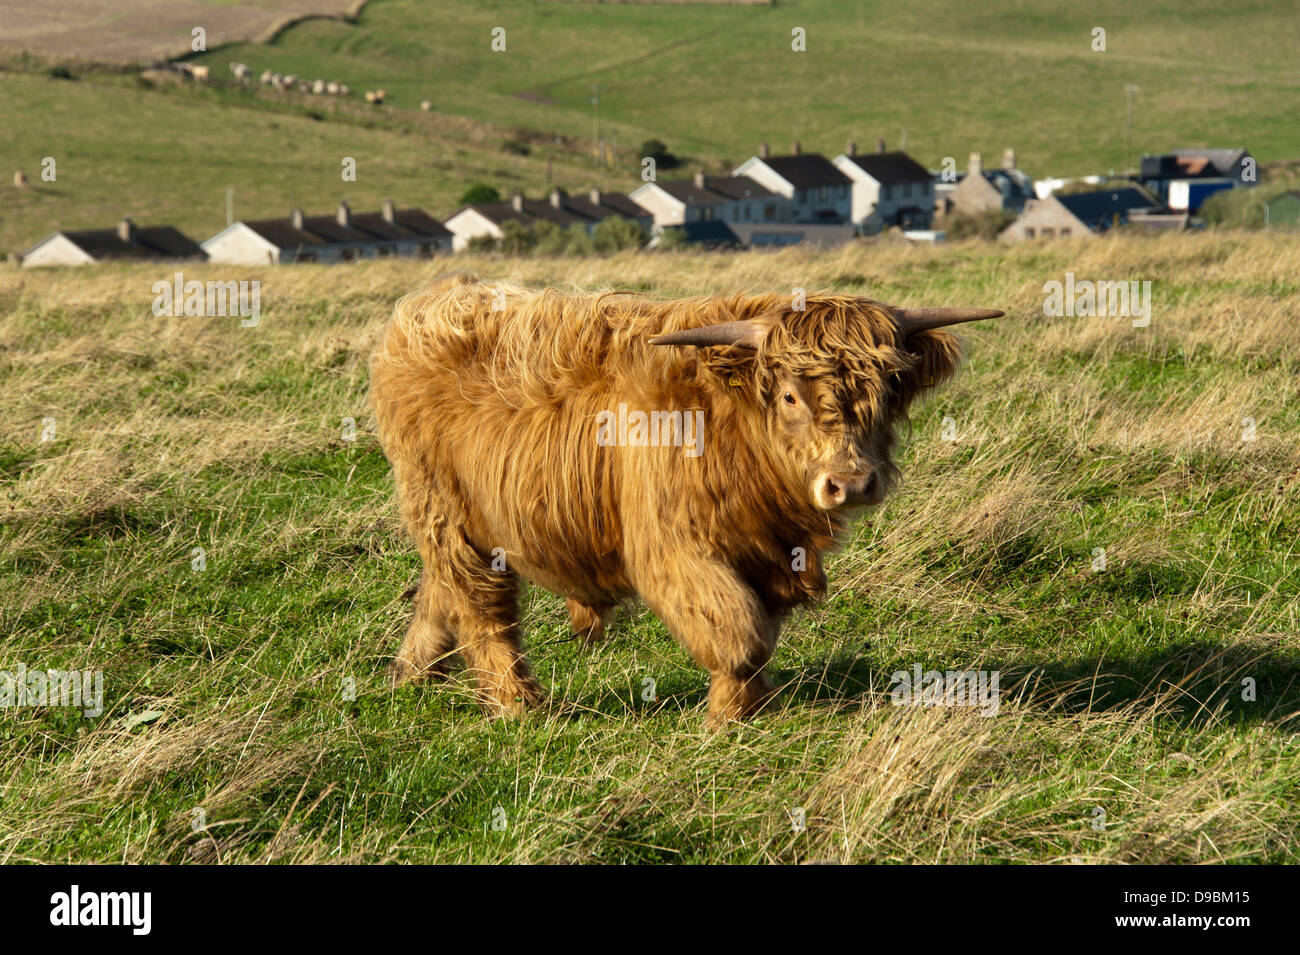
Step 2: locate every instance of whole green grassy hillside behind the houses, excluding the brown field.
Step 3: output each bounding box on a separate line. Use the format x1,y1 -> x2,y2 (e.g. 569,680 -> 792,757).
0,0 -> 1300,251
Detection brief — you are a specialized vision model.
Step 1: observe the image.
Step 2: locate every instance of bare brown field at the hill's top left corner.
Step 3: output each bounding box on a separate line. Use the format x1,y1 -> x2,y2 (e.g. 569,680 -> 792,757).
0,0 -> 365,64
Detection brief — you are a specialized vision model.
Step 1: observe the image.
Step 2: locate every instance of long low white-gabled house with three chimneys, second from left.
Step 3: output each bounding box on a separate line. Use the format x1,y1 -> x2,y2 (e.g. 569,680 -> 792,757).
203,200 -> 451,265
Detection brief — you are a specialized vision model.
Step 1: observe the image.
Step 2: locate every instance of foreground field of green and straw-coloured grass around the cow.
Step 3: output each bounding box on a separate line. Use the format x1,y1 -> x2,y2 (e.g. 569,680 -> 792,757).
0,233 -> 1300,863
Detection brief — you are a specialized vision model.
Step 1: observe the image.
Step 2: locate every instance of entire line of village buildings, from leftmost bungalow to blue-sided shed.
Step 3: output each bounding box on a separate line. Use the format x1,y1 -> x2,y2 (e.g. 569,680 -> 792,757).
22,140 -> 1255,265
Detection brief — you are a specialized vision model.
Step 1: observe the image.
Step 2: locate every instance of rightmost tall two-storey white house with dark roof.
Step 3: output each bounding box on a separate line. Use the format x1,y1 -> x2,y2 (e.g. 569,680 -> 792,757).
835,142 -> 935,234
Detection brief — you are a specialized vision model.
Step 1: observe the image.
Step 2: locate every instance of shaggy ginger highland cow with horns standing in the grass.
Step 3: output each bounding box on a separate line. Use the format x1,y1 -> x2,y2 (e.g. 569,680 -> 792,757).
372,275 -> 1002,726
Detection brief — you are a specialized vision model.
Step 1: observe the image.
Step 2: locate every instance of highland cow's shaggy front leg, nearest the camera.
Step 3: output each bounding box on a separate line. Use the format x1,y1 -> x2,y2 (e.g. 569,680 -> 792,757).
637,559 -> 780,729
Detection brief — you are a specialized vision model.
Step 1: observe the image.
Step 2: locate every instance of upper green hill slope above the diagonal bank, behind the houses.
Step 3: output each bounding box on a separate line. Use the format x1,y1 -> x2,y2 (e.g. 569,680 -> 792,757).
195,0 -> 1300,175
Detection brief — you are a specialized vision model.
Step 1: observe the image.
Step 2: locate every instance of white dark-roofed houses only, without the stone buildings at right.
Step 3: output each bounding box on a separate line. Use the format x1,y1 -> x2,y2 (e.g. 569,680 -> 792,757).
22,142 -> 933,266
